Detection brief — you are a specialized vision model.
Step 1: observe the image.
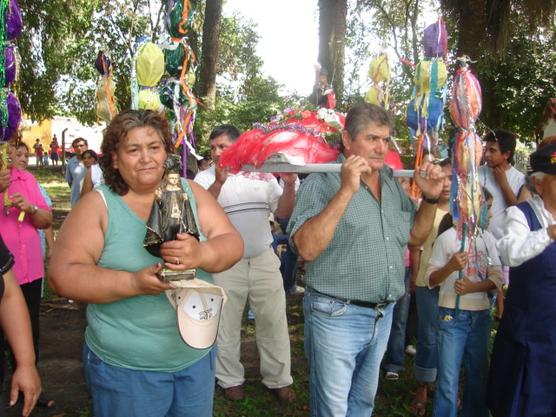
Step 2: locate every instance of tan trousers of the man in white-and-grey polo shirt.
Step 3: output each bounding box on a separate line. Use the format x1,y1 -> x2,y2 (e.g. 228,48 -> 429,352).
213,248 -> 293,388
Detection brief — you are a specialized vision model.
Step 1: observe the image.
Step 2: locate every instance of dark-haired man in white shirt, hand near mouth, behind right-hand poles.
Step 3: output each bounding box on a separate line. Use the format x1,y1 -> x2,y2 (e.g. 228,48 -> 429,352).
479,129 -> 530,240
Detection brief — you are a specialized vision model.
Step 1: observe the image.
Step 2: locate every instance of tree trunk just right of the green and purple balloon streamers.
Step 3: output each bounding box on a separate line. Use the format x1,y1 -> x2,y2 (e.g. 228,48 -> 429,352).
197,0 -> 222,109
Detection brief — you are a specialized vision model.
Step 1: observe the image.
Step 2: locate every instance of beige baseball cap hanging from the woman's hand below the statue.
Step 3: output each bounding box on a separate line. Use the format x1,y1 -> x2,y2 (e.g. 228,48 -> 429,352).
166,278 -> 226,349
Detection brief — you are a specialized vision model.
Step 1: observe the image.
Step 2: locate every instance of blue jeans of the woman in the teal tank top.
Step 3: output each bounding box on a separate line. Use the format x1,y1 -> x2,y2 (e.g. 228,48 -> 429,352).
83,343 -> 216,417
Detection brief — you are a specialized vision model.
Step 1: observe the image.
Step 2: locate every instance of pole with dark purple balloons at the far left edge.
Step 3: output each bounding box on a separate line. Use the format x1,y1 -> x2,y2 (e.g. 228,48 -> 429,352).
0,0 -> 25,218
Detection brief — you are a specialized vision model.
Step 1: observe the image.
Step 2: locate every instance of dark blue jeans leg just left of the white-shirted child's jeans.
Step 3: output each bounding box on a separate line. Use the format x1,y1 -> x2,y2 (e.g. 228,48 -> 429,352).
414,287 -> 438,382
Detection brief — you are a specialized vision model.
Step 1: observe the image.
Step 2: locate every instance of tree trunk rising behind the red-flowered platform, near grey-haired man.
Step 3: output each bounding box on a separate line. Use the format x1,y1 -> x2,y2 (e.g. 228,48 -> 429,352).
318,0 -> 347,102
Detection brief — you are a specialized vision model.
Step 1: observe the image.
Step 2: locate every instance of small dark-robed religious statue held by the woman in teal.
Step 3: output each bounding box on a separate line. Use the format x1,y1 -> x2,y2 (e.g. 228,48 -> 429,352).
143,155 -> 199,281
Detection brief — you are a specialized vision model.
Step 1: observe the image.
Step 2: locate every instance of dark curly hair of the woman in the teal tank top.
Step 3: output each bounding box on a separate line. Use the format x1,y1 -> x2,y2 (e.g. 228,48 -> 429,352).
99,110 -> 174,195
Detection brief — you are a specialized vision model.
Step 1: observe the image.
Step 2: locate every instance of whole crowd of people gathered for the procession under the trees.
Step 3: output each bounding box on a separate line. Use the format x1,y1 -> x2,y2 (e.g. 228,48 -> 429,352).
0,104 -> 556,417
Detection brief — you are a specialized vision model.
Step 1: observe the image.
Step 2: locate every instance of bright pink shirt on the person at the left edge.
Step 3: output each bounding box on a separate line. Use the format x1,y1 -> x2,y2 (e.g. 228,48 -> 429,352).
0,168 -> 50,285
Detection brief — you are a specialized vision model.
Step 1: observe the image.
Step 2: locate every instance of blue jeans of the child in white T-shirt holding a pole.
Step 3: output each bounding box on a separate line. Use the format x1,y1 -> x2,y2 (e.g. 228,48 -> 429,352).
432,307 -> 490,417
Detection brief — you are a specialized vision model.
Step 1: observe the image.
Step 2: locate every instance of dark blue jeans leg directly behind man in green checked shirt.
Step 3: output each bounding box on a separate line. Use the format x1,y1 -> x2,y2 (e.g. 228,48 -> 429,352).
382,268 -> 411,372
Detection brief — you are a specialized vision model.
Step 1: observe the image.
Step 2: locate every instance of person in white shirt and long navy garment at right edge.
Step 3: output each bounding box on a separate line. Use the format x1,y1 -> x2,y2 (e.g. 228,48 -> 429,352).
487,141 -> 556,417
